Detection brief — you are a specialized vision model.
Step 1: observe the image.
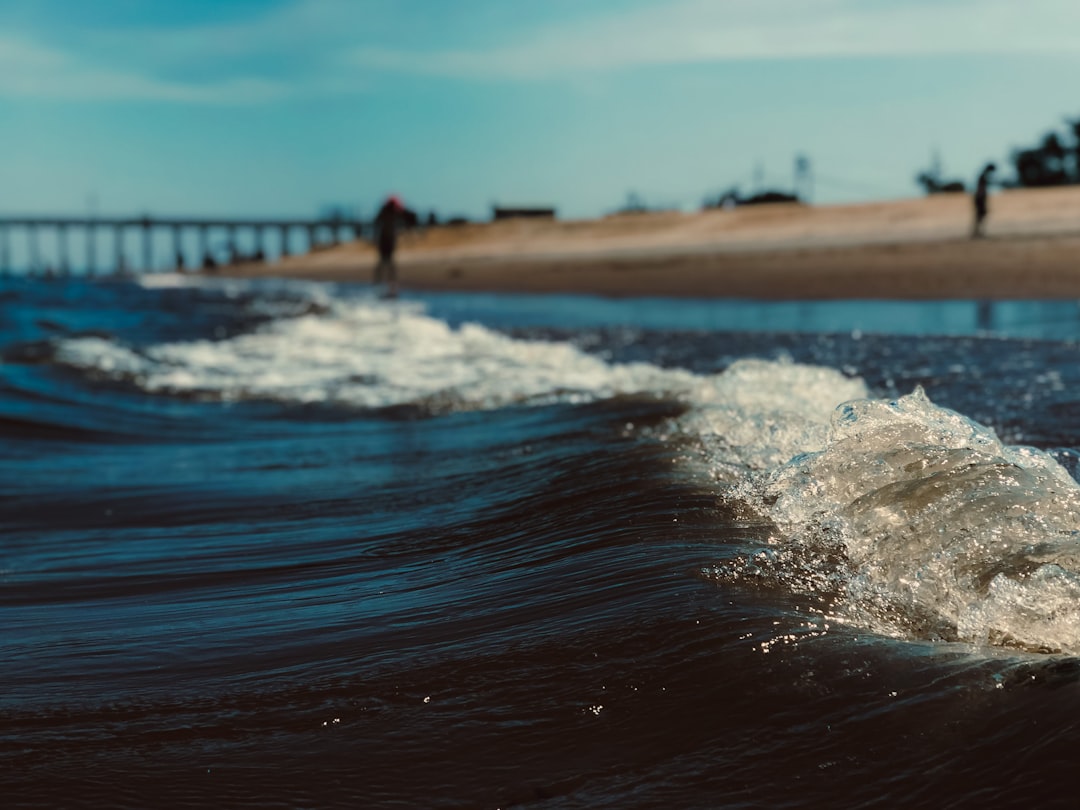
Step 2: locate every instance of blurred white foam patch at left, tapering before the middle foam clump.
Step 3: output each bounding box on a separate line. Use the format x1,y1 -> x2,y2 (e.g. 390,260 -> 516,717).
55,299 -> 717,411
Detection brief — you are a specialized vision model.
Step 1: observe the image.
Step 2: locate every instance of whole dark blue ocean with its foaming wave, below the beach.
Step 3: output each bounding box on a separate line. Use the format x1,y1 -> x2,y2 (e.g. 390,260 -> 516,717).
0,275 -> 1080,809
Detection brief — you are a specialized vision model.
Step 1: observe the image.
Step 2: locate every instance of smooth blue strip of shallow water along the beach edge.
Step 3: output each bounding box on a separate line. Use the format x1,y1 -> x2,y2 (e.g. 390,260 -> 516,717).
416,294 -> 1080,340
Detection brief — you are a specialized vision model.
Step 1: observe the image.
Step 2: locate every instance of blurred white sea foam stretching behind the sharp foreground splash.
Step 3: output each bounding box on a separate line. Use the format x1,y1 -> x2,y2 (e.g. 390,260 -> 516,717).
56,291 -> 865,414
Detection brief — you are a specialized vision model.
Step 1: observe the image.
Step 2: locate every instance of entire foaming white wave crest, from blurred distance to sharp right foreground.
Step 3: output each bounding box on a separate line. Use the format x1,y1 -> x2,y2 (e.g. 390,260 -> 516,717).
54,296 -> 1080,653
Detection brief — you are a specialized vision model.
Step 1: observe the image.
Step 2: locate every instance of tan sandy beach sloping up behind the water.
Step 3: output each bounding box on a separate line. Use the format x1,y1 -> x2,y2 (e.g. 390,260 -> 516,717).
214,187 -> 1080,299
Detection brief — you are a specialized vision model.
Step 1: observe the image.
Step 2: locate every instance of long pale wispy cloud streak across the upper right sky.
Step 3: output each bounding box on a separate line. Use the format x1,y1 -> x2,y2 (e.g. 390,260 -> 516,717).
351,0 -> 1080,79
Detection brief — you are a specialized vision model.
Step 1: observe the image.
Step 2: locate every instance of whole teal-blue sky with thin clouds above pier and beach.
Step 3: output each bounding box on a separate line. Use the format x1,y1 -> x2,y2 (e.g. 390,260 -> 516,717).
0,0 -> 1080,217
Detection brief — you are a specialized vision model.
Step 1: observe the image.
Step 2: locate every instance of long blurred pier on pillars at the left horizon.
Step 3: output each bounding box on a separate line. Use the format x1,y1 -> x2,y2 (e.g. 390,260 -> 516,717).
0,216 -> 372,275
